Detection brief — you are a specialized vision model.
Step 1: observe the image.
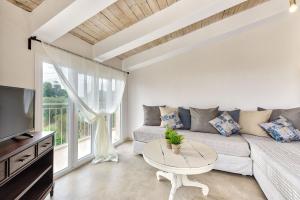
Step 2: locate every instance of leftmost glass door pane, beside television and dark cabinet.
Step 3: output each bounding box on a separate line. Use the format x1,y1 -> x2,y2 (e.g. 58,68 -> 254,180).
43,63 -> 69,173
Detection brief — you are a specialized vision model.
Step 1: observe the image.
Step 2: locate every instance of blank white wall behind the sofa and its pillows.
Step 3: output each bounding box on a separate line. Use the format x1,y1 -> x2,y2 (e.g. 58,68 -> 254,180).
128,12 -> 300,134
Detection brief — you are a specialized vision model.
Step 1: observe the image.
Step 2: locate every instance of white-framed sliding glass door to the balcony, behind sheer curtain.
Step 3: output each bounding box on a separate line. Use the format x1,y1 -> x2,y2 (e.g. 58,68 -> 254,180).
36,59 -> 122,177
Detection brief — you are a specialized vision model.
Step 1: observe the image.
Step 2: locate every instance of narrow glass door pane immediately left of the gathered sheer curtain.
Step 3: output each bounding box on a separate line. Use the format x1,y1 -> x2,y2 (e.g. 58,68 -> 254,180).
77,111 -> 92,159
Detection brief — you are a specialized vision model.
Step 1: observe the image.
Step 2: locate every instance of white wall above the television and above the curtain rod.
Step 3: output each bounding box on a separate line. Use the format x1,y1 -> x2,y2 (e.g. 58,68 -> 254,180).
0,0 -> 92,88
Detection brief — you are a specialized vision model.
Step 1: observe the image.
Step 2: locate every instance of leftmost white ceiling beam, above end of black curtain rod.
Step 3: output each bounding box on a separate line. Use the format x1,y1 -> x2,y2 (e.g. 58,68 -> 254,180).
30,0 -> 117,42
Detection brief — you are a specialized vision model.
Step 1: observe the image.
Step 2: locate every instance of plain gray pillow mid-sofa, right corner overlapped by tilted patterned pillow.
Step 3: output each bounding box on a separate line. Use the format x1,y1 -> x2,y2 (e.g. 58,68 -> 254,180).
190,107 -> 219,134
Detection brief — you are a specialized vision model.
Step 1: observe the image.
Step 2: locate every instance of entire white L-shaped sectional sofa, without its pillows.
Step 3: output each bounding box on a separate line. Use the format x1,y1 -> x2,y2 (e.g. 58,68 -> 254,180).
133,126 -> 300,200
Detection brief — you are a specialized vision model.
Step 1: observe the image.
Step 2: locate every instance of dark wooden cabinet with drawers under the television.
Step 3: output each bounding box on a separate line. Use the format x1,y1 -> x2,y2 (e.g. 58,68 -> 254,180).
0,132 -> 54,200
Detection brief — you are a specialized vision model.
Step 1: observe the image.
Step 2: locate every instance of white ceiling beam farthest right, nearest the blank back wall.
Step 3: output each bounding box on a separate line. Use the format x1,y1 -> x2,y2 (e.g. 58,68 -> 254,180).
122,0 -> 289,71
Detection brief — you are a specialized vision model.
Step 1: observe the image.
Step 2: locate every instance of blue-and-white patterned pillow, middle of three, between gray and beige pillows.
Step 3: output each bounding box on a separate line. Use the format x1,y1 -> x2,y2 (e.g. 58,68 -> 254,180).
209,112 -> 240,136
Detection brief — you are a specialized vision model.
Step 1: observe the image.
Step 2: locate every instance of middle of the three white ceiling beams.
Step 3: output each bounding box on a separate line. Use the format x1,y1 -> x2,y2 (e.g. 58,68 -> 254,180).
94,0 -> 246,62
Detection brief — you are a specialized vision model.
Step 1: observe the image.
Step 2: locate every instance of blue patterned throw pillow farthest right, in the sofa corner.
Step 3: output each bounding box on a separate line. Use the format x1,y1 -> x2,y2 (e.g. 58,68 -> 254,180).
260,116 -> 300,142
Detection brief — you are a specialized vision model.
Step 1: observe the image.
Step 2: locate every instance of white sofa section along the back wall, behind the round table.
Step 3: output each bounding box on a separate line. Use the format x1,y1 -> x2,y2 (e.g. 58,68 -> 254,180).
133,126 -> 253,175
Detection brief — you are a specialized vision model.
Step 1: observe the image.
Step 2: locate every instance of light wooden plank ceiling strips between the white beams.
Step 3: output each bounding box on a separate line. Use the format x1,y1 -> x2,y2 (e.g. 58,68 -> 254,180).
7,0 -> 269,59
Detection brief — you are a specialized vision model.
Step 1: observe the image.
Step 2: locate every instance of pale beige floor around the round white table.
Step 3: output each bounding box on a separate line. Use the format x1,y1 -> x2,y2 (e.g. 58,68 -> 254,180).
48,142 -> 266,200
